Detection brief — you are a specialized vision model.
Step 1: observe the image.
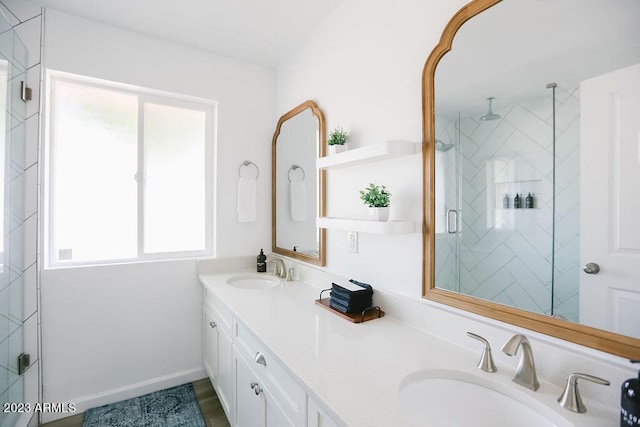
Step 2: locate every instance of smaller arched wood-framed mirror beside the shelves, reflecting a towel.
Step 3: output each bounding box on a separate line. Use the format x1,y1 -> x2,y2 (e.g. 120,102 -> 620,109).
271,100 -> 326,266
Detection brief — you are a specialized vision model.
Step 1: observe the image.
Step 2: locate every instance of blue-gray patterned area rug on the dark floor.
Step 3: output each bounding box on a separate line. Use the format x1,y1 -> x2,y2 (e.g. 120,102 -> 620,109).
82,384 -> 205,427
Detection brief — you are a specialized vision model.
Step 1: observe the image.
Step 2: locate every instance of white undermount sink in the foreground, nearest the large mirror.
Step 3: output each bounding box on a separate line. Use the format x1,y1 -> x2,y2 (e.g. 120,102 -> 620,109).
400,370 -> 567,427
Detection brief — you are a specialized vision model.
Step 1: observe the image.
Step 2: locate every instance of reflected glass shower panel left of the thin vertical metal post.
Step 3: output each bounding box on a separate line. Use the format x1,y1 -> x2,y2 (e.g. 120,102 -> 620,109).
435,96 -> 554,315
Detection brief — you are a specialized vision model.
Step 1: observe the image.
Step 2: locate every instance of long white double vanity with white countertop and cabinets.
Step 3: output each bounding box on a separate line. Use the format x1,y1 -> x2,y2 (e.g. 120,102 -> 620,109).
198,258 -> 618,427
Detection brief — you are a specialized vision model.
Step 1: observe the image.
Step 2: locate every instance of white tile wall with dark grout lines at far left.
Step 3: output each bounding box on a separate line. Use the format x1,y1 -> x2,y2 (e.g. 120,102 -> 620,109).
0,0 -> 43,425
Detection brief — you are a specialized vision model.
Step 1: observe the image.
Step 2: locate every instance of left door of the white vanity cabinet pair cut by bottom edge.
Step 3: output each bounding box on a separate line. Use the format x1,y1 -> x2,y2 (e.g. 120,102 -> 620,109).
233,349 -> 267,427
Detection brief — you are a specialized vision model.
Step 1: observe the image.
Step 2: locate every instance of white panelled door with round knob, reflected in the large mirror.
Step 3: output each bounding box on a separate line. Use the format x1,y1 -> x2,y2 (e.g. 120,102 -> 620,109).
580,64 -> 640,338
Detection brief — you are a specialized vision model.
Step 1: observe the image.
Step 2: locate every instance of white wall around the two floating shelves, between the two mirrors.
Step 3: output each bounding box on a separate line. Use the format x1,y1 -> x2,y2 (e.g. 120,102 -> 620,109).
277,0 -> 466,298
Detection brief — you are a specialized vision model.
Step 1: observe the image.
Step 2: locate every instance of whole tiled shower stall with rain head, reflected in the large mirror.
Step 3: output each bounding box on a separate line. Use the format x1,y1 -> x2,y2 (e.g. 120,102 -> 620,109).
435,84 -> 580,321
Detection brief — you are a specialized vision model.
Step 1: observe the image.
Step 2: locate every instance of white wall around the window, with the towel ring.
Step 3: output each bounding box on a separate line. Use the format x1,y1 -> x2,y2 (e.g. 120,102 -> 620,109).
41,10 -> 275,421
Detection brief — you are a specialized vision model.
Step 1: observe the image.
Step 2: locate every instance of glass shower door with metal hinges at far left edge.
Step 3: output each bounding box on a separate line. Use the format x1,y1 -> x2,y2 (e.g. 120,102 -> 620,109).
0,16 -> 29,426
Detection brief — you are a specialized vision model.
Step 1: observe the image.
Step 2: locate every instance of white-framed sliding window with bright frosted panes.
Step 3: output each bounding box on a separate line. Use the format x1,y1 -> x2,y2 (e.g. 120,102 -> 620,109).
45,73 -> 215,266
